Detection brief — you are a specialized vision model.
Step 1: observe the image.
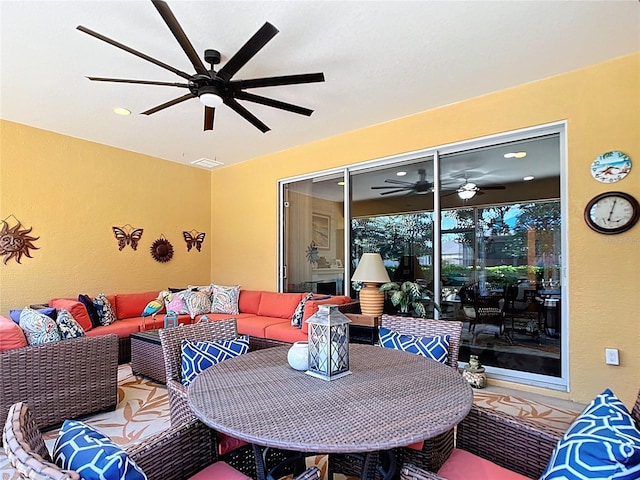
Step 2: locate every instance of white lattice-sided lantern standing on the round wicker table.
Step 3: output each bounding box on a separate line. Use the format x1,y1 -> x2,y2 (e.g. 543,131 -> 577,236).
307,305 -> 351,380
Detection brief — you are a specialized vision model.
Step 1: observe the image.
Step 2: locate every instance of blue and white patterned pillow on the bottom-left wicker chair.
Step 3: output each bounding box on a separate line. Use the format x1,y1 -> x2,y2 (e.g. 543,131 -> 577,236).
53,420 -> 147,480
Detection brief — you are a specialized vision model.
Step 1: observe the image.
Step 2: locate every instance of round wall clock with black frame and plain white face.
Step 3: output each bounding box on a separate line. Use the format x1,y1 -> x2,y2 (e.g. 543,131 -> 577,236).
584,192 -> 640,234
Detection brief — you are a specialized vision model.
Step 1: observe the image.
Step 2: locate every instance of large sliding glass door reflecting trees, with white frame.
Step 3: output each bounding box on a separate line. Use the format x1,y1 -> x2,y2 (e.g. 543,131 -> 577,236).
280,124 -> 568,388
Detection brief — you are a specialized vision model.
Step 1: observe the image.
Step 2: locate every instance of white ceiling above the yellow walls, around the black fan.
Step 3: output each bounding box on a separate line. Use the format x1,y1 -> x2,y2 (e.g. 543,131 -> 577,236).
0,0 -> 640,171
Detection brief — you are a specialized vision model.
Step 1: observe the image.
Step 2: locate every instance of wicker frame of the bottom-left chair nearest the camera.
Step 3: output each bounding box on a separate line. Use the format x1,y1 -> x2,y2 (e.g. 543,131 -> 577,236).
2,402 -> 320,480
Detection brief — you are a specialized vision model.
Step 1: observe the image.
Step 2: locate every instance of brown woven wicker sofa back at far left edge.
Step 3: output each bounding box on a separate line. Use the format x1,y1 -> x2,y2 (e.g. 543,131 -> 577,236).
0,334 -> 118,428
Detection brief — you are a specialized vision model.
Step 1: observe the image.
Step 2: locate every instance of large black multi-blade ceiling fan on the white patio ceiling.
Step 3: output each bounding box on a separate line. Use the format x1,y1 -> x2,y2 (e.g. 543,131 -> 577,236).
77,0 -> 324,133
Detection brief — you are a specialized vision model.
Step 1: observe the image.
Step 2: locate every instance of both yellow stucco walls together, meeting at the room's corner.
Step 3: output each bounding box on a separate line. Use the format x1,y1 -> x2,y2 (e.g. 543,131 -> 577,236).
0,54 -> 640,404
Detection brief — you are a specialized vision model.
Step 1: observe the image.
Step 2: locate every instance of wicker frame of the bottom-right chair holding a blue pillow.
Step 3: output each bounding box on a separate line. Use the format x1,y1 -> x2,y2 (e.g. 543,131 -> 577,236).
400,392 -> 640,480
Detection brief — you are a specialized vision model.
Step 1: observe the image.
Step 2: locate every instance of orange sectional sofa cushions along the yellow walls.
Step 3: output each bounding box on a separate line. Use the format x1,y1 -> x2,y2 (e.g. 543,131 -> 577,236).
0,289 -> 359,363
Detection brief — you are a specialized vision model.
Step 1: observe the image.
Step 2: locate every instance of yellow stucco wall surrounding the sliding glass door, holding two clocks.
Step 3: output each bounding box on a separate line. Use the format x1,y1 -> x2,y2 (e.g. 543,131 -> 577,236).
211,54 -> 640,404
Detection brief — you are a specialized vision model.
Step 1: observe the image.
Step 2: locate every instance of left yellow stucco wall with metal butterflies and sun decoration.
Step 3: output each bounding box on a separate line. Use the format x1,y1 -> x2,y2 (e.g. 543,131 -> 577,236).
0,121 -> 213,310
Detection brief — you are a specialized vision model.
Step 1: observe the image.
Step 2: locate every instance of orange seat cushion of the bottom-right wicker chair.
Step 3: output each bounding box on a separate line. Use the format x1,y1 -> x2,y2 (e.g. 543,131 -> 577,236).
438,448 -> 530,480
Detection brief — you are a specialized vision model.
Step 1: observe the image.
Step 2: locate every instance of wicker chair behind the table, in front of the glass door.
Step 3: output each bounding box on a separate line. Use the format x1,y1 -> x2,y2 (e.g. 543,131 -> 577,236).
329,315 -> 462,478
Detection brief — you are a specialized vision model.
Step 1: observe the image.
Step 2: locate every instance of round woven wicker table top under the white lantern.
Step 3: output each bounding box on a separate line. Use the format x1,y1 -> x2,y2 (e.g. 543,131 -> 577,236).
188,344 -> 473,453
